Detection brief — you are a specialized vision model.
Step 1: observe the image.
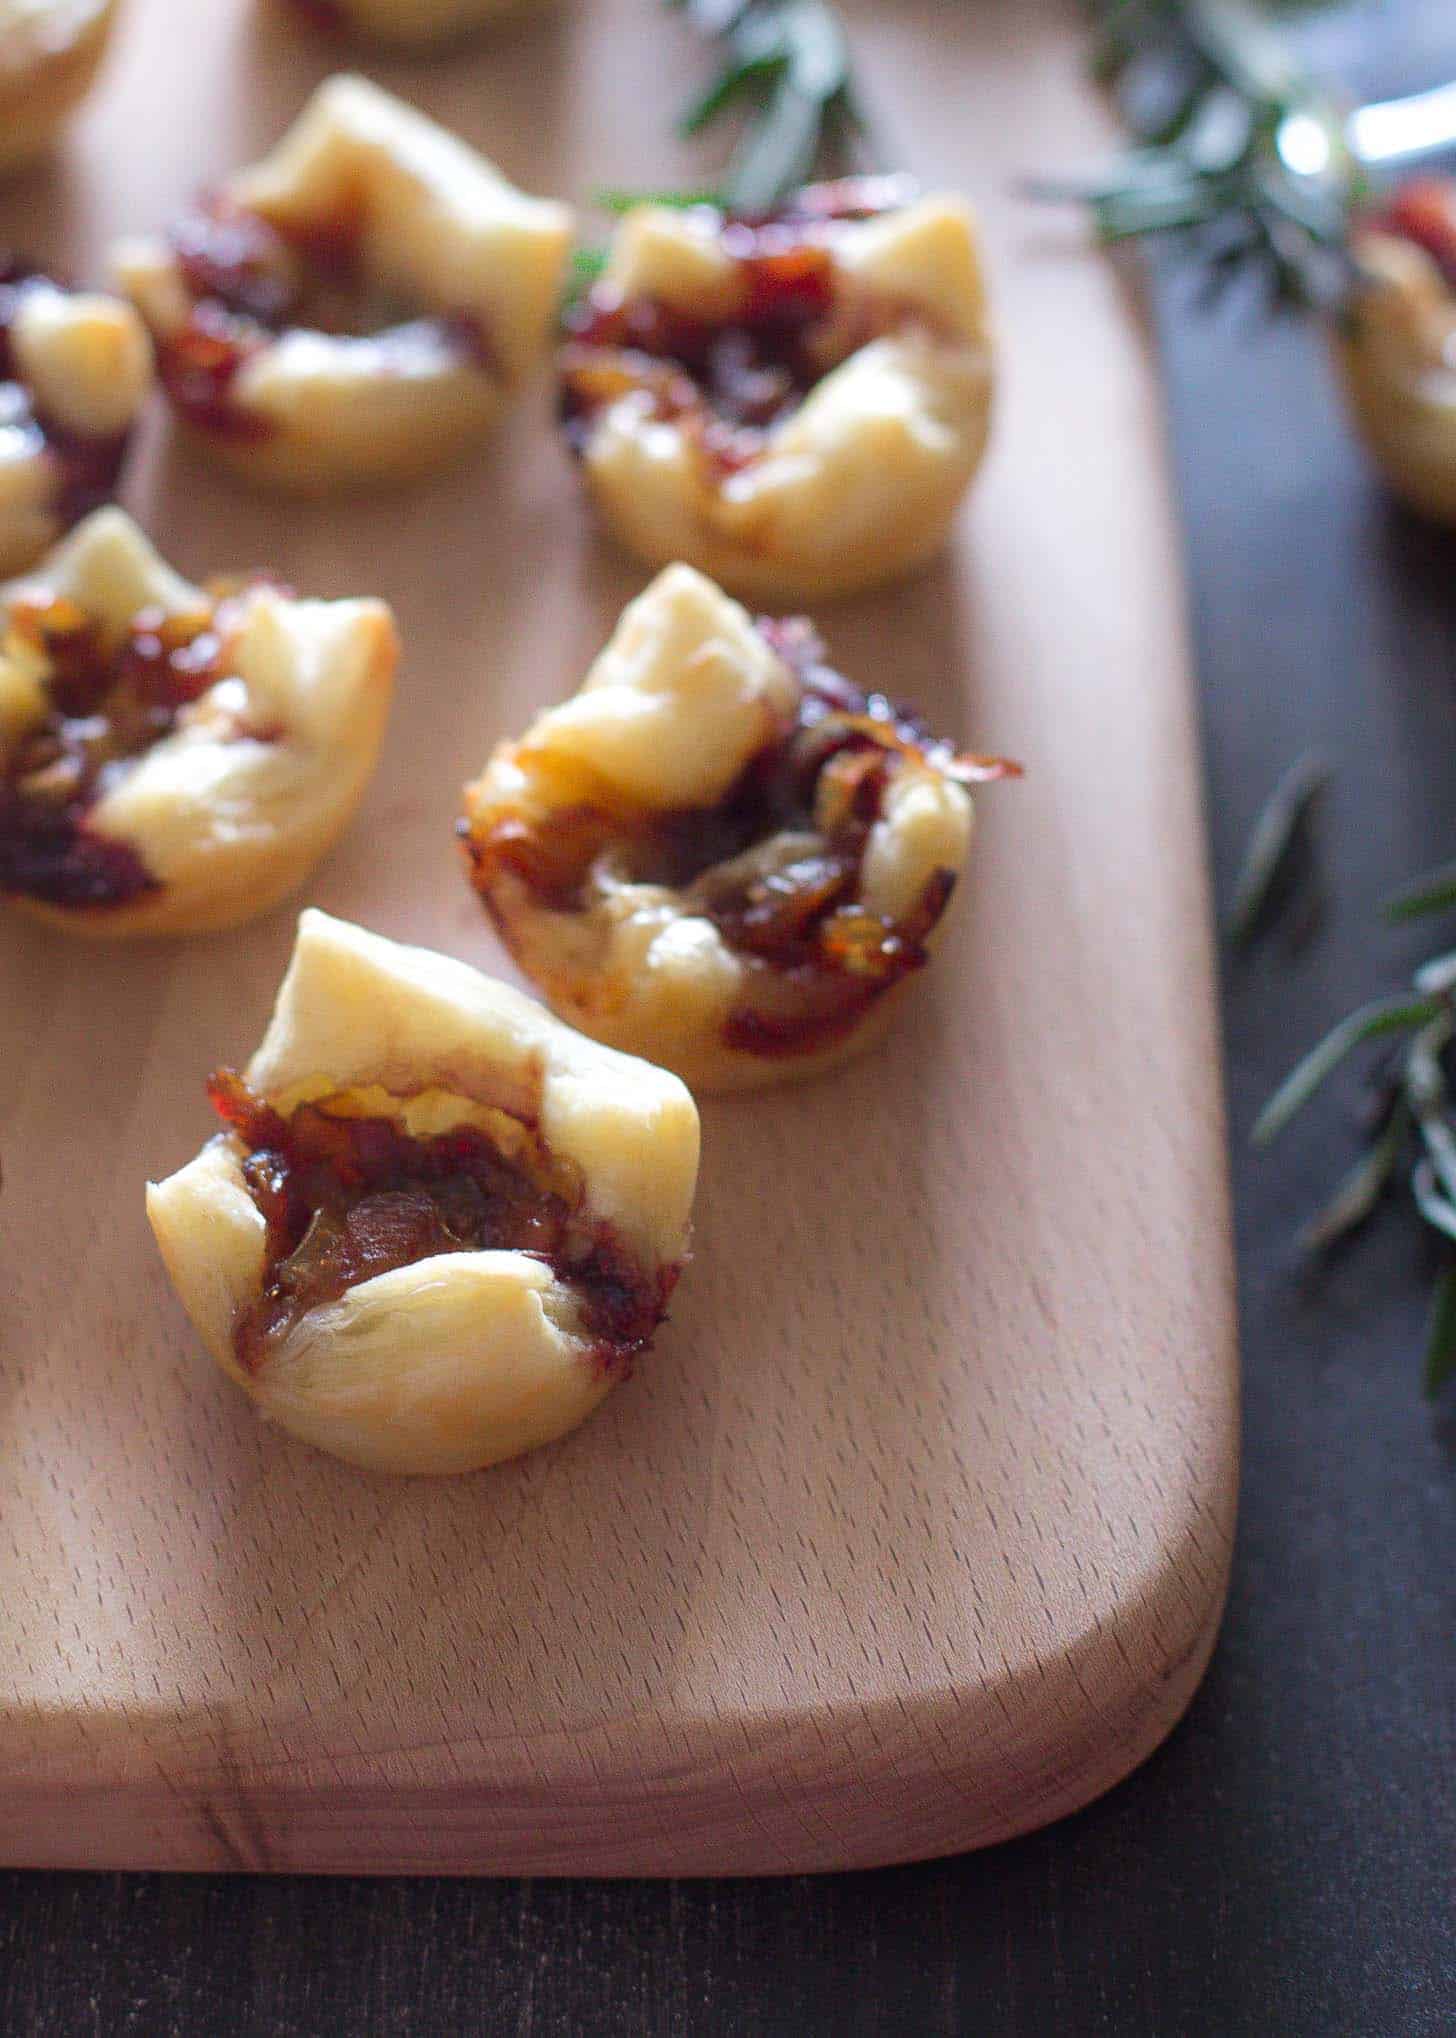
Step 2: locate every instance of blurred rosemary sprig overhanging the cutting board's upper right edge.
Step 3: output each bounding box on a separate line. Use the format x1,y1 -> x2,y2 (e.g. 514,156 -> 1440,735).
1028,0 -> 1364,308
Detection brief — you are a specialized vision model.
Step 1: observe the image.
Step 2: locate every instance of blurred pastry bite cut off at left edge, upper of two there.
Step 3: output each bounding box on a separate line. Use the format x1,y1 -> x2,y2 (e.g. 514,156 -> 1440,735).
0,257 -> 151,577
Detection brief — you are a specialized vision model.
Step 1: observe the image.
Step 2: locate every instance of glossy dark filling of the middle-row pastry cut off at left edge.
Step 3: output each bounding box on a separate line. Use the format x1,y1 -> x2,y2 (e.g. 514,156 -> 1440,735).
0,599 -> 220,907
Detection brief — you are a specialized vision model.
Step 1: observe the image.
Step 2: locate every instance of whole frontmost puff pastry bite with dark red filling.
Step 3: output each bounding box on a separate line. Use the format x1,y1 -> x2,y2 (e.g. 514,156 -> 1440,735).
147,911 -> 697,1471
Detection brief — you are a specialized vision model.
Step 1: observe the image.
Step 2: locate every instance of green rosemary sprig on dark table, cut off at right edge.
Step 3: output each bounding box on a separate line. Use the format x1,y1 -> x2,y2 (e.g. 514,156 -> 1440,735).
1252,950 -> 1456,1396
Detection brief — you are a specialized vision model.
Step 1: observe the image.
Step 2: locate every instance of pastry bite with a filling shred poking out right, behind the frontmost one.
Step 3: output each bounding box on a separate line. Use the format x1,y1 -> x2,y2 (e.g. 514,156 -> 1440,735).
461,565 -> 1016,1090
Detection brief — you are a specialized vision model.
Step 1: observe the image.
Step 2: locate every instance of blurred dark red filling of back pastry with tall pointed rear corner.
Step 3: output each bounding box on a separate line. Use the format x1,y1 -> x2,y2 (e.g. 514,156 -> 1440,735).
157,200 -> 493,438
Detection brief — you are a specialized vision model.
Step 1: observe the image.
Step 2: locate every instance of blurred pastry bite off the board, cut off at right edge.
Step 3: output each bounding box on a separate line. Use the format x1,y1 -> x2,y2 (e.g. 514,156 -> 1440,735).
1334,177 -> 1456,524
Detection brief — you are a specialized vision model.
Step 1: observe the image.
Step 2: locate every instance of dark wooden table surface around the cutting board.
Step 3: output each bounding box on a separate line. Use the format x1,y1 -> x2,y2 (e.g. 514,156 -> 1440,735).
0,0 -> 1456,2038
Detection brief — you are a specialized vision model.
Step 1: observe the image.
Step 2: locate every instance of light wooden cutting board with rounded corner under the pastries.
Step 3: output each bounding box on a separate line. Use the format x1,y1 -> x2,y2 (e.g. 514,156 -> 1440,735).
0,0 -> 1236,1873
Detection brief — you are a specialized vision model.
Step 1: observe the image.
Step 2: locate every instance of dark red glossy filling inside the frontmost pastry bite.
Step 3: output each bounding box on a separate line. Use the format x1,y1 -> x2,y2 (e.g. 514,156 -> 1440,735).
208,1070 -> 677,1374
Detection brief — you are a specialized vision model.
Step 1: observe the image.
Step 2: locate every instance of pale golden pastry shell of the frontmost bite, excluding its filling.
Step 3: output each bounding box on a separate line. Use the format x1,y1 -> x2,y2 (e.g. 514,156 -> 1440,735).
147,911 -> 697,1471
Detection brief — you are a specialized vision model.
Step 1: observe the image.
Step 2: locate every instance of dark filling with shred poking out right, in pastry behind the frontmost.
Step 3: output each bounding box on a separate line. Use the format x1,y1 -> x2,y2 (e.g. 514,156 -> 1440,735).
463,622 -> 1016,1056
